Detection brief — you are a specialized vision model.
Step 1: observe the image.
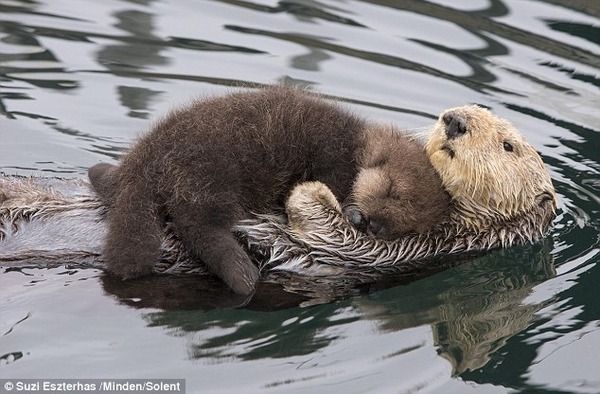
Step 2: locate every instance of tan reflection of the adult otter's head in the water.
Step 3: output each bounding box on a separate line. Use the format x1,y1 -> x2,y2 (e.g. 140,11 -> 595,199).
433,248 -> 555,373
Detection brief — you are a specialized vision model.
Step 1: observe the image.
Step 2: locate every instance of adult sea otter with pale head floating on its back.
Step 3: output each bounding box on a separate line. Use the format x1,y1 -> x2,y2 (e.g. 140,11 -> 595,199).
0,100 -> 556,288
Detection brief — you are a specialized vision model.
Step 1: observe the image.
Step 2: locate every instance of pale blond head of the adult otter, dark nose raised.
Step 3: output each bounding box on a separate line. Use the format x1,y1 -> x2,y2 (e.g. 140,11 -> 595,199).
426,105 -> 556,231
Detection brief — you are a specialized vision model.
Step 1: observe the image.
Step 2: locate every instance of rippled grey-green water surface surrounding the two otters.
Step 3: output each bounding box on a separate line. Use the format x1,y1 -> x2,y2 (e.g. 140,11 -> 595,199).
0,0 -> 600,393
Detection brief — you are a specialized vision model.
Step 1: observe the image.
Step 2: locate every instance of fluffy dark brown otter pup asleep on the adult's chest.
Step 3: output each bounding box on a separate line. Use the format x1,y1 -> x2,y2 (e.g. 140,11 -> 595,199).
89,86 -> 450,294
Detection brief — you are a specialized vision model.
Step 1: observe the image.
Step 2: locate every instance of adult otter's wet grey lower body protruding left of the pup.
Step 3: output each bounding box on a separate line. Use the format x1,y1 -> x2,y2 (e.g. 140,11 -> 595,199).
0,176 -> 106,266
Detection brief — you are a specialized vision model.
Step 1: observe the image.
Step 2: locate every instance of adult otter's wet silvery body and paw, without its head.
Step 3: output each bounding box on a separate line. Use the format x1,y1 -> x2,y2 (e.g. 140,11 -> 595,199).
0,174 -> 545,281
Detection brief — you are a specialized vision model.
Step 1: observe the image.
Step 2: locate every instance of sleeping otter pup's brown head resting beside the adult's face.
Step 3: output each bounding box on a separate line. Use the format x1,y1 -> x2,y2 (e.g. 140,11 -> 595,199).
353,127 -> 450,239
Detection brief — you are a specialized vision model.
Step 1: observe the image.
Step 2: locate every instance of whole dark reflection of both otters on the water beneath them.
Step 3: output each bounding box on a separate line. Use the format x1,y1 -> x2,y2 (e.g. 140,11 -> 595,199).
97,240 -> 556,374
